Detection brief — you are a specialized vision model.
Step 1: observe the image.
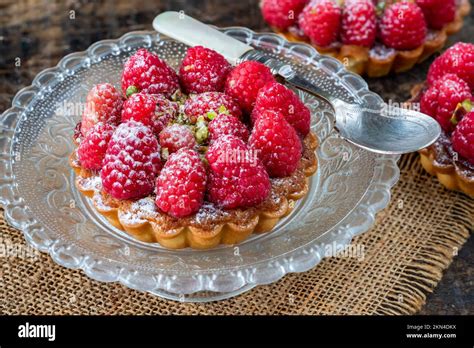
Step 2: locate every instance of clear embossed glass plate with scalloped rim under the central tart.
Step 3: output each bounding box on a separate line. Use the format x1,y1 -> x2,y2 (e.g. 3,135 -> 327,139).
0,27 -> 399,301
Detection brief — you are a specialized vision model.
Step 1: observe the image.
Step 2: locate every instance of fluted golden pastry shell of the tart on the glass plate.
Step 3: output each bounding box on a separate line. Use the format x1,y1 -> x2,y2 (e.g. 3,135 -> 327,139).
69,132 -> 319,249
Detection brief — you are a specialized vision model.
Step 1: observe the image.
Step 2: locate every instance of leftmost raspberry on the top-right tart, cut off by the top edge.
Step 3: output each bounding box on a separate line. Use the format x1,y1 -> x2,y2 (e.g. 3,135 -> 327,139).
262,0 -> 307,30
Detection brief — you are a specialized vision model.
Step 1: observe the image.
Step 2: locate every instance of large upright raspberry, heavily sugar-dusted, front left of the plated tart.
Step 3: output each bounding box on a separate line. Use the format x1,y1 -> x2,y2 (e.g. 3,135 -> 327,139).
100,121 -> 161,199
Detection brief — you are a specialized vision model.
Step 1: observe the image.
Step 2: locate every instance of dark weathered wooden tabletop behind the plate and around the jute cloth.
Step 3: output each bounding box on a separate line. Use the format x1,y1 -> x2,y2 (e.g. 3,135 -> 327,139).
0,0 -> 474,314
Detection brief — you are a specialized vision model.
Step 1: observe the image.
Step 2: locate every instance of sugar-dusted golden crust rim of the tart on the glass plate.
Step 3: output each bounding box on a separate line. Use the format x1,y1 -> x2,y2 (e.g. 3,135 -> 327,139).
69,132 -> 319,249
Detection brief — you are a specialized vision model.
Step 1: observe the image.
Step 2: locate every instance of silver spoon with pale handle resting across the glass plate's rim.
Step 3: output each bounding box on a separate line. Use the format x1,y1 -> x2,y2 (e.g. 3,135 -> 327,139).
153,11 -> 441,154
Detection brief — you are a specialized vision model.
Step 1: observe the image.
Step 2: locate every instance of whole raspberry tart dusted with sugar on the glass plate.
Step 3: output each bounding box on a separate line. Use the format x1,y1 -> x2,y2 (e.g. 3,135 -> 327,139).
70,47 -> 318,249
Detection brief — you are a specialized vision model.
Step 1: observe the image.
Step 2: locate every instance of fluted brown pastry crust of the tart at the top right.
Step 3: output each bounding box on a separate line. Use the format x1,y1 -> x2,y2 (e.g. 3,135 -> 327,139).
272,0 -> 471,77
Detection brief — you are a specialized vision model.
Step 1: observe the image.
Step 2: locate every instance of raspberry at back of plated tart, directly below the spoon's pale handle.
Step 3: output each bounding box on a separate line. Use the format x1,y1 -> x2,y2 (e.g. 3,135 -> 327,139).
179,46 -> 232,93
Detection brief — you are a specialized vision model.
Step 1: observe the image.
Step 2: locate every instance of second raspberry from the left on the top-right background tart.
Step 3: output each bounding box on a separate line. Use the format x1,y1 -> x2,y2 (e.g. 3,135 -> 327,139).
298,0 -> 341,47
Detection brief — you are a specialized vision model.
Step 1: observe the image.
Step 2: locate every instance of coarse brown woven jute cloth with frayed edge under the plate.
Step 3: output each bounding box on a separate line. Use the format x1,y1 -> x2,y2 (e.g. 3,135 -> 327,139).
0,154 -> 474,315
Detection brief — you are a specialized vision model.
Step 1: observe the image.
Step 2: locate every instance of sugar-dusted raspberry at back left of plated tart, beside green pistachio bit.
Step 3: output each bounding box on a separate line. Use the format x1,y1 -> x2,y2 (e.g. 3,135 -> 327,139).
122,48 -> 179,98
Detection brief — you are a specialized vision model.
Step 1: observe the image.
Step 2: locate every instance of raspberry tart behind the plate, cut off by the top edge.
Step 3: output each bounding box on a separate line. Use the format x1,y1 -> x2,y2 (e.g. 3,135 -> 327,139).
261,0 -> 471,77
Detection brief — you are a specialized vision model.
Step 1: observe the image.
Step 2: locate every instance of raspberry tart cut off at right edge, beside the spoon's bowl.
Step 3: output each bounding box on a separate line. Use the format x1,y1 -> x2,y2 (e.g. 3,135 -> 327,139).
410,43 -> 474,197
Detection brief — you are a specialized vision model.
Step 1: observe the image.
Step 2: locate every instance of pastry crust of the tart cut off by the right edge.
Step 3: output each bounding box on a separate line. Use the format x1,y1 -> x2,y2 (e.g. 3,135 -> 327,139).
409,83 -> 474,197
